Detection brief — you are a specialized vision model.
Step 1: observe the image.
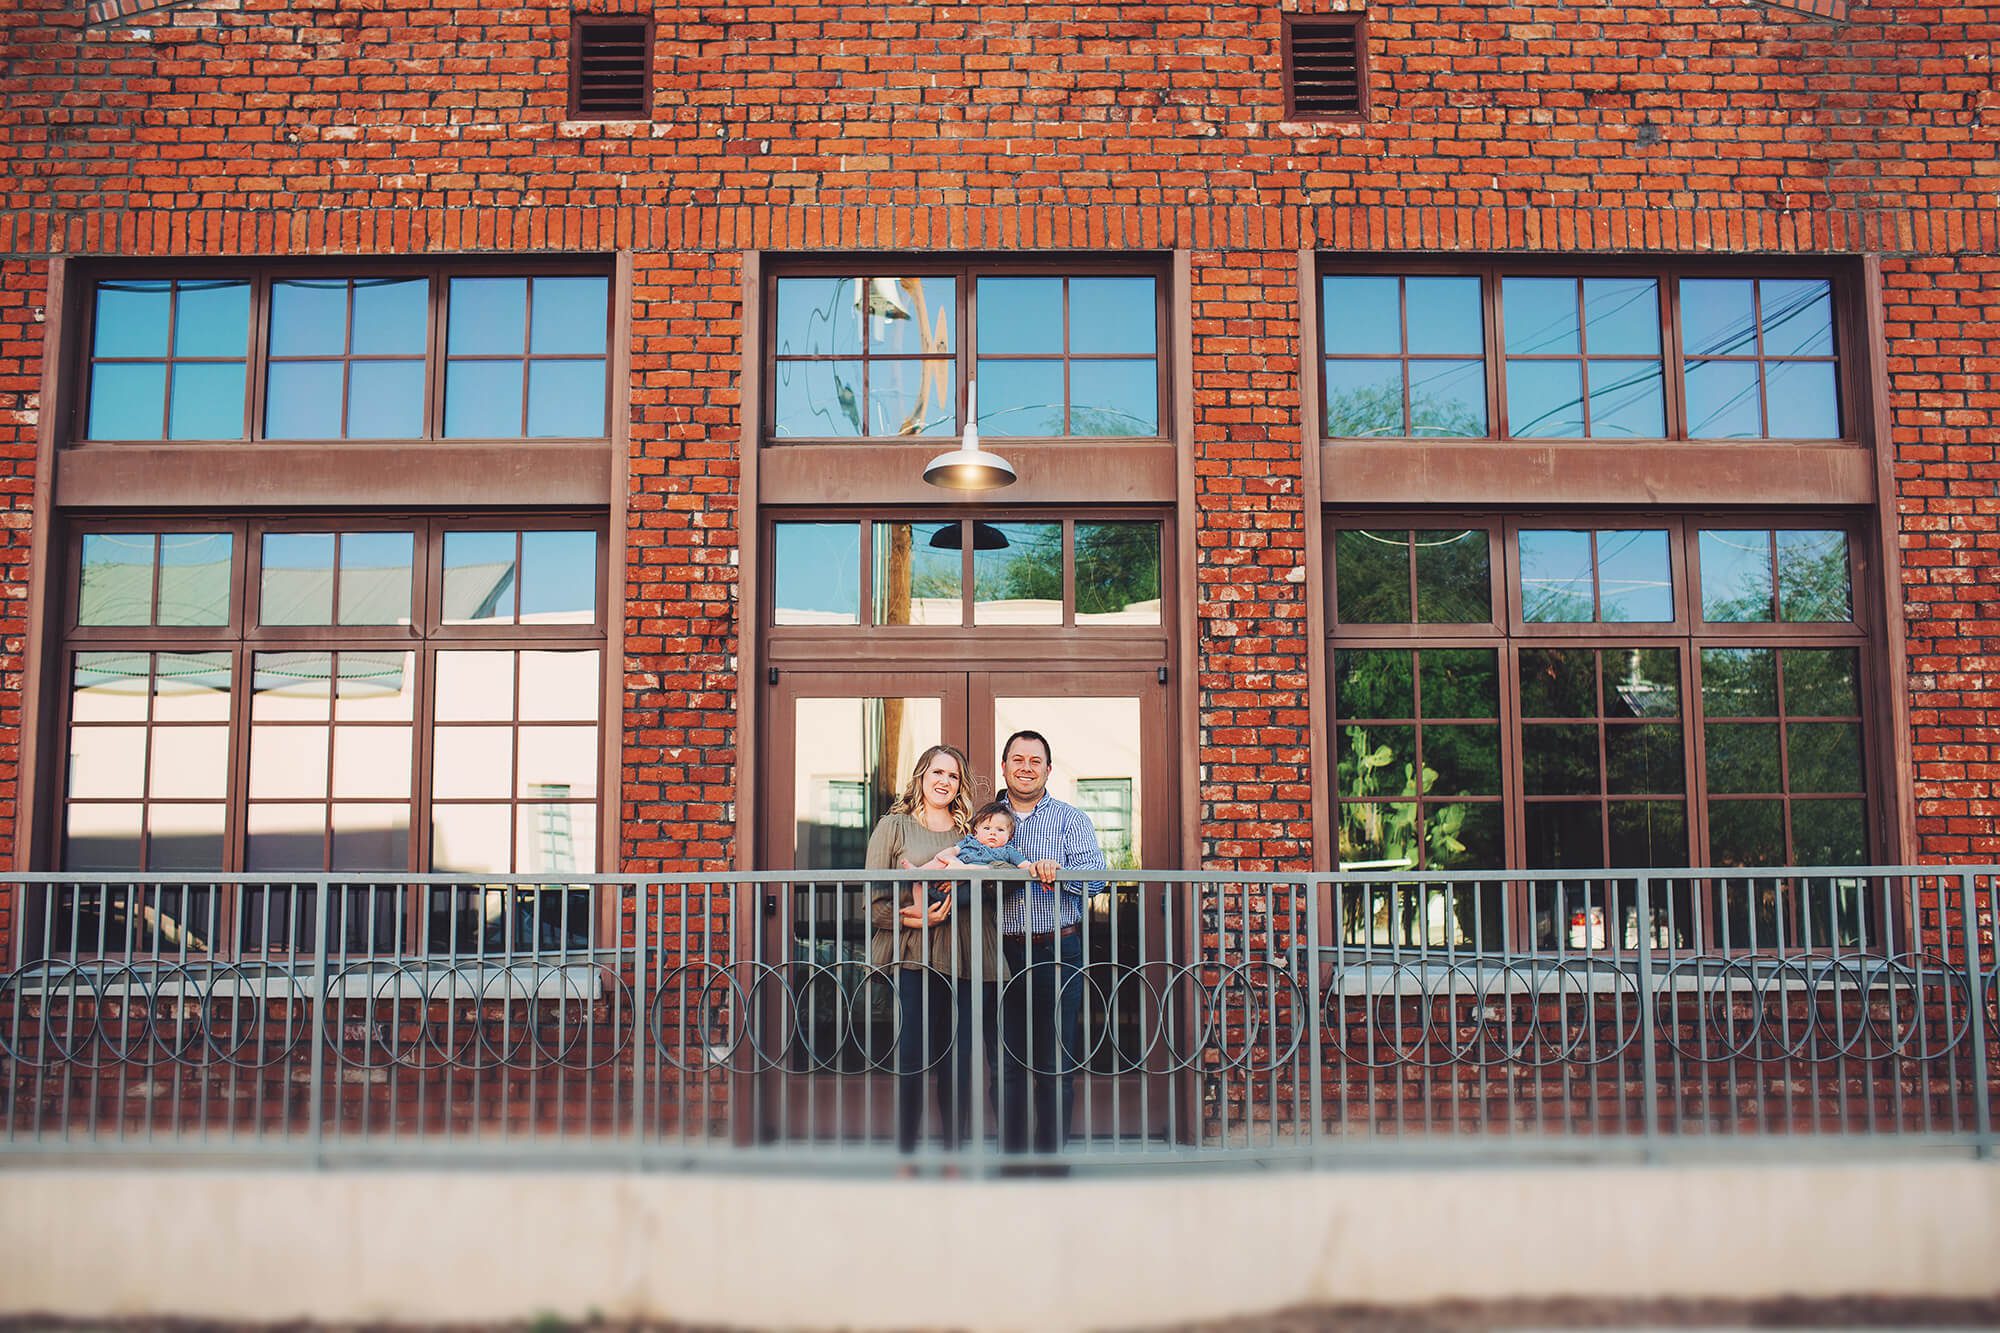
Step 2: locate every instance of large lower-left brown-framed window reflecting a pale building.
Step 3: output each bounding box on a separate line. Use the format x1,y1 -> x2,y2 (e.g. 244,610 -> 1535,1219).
52,514 -> 606,951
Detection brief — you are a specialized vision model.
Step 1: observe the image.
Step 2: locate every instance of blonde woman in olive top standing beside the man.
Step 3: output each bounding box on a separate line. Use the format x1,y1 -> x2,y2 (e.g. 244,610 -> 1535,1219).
868,745 -> 1000,1153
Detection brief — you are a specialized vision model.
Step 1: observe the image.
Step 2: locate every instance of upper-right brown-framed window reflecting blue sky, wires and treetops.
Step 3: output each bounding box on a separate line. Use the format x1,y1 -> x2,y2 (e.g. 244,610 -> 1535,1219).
1318,258 -> 1858,442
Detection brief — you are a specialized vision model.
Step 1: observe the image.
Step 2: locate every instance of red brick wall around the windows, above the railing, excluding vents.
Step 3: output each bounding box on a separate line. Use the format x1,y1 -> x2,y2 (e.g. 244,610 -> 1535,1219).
0,0 -> 2000,867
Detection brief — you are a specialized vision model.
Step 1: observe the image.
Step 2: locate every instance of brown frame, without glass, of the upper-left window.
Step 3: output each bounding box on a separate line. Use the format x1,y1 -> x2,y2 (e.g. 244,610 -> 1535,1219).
64,256 -> 620,448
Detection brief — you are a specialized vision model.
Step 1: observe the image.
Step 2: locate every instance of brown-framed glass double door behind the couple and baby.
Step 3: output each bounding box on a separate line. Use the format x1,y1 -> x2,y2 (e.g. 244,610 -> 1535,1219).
758,669 -> 1174,1139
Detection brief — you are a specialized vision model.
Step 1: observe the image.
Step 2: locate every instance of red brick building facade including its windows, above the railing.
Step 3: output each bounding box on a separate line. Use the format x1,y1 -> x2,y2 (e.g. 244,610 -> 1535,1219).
0,0 -> 2000,960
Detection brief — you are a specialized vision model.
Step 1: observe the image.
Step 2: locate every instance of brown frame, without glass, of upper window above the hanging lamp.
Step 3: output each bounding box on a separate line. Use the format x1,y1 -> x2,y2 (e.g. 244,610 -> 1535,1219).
760,252 -> 1176,452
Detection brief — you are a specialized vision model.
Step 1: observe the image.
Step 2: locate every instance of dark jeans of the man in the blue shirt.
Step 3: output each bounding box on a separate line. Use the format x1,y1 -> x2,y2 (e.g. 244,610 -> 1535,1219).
988,931 -> 1084,1153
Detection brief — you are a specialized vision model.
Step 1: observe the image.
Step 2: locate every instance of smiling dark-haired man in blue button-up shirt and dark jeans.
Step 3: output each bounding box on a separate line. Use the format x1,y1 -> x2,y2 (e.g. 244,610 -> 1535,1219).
992,731 -> 1106,1153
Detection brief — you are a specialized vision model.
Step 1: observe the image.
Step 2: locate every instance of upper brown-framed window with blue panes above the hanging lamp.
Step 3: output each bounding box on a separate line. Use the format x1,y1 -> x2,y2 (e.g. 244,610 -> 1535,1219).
764,258 -> 1170,442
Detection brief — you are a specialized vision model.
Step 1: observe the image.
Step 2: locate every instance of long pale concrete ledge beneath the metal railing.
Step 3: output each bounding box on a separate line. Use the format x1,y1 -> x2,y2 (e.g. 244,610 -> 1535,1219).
0,1163 -> 2000,1329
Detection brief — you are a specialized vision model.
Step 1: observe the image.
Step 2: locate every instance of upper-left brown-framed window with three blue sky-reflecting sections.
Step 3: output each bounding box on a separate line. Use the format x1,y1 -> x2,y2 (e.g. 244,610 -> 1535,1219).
70,260 -> 612,442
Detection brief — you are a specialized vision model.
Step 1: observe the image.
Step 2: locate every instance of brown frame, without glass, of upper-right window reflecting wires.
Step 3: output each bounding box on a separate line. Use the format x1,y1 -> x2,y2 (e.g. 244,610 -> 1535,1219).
1310,254 -> 1866,448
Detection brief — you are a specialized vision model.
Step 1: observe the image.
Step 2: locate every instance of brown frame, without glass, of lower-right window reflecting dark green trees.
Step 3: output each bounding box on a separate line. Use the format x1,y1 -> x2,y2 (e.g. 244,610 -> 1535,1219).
1322,510 -> 1890,951
